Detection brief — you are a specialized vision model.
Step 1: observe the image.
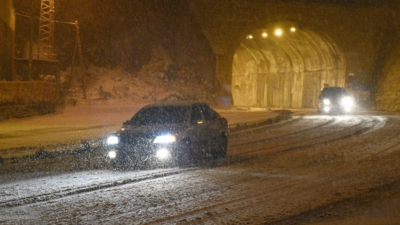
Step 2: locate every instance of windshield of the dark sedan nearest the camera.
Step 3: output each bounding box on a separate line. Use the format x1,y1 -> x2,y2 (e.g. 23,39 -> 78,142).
131,106 -> 190,125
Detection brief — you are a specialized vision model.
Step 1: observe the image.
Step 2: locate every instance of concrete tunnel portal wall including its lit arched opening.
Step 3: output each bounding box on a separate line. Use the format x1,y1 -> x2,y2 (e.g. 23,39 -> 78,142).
187,0 -> 400,108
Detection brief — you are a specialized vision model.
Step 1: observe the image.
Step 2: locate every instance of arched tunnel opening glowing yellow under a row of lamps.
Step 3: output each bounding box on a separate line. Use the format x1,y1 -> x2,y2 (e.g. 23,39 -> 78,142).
232,24 -> 346,108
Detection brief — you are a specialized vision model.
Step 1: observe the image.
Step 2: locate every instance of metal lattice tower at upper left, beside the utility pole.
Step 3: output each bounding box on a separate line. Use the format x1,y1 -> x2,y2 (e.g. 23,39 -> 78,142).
38,0 -> 55,60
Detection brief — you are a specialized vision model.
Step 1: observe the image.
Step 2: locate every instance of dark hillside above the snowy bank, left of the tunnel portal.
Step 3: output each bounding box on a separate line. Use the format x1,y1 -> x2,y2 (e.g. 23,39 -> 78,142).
14,0 -> 218,104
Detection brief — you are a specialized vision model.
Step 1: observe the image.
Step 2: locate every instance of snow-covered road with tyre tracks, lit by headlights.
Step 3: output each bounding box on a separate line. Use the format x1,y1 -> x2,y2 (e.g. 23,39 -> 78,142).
0,115 -> 400,224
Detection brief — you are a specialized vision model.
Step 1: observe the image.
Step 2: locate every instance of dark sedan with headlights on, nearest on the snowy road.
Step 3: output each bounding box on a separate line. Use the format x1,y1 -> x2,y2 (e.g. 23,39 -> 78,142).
106,102 -> 229,168
